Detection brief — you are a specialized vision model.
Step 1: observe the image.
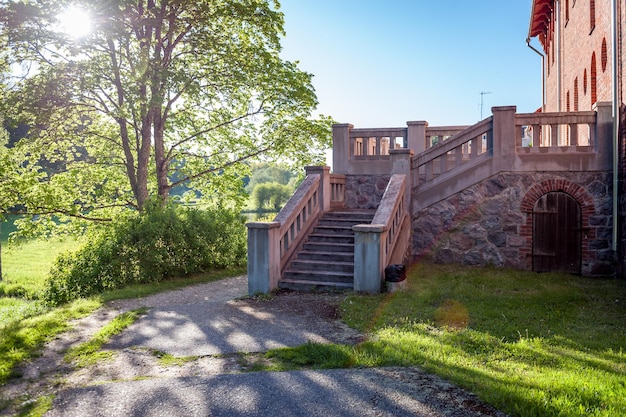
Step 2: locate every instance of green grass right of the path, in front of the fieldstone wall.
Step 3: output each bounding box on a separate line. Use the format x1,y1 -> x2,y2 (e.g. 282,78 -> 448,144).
257,265 -> 626,417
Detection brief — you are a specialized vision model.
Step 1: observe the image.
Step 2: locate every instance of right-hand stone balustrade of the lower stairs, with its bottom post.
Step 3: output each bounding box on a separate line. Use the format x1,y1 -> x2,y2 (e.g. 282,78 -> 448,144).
352,174 -> 410,294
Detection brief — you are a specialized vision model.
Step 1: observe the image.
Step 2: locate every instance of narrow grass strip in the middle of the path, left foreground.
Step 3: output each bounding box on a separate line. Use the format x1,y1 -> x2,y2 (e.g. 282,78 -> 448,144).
64,307 -> 148,368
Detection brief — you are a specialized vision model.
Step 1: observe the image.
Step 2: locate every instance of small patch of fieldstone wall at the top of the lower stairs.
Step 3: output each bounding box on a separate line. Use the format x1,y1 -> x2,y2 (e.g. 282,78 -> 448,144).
345,175 -> 391,210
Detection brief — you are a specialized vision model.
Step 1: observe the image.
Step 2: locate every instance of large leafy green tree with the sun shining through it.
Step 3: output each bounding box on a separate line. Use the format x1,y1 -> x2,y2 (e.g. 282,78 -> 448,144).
0,0 -> 330,228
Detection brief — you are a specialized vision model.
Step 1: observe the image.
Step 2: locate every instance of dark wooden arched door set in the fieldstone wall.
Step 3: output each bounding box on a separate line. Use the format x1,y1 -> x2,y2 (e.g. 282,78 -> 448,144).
533,191 -> 582,275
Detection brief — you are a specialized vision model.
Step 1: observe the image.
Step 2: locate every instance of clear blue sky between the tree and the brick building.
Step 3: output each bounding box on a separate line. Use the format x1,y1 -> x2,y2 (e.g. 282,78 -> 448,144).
280,0 -> 541,127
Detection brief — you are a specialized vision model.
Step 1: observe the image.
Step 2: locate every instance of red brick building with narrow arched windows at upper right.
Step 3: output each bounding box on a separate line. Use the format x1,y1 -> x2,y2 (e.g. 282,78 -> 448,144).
528,0 -> 626,276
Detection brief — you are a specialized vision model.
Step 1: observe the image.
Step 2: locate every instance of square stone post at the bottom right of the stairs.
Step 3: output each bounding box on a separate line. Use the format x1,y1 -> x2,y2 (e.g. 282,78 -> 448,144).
352,224 -> 385,294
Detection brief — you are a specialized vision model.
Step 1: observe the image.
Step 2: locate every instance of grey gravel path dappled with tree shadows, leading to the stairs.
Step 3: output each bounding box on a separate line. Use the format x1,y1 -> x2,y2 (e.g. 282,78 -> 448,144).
0,276 -> 504,417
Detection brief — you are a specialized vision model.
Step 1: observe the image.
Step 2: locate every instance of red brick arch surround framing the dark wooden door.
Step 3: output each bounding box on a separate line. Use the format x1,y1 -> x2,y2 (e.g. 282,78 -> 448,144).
520,179 -> 595,270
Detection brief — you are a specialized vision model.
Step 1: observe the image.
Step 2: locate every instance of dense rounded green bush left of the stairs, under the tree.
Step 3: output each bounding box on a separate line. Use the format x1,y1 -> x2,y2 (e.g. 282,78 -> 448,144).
43,206 -> 246,305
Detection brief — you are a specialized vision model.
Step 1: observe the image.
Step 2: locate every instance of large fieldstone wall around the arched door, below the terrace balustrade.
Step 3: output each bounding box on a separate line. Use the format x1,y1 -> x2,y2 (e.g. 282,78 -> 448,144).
412,172 -> 615,276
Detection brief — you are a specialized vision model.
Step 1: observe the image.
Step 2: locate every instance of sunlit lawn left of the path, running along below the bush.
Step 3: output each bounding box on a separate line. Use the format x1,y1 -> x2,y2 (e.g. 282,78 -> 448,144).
0,223 -> 245,386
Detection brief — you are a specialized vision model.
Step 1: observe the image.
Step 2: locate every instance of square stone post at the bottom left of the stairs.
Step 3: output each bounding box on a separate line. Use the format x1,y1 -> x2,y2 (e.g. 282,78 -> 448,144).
246,222 -> 280,295
